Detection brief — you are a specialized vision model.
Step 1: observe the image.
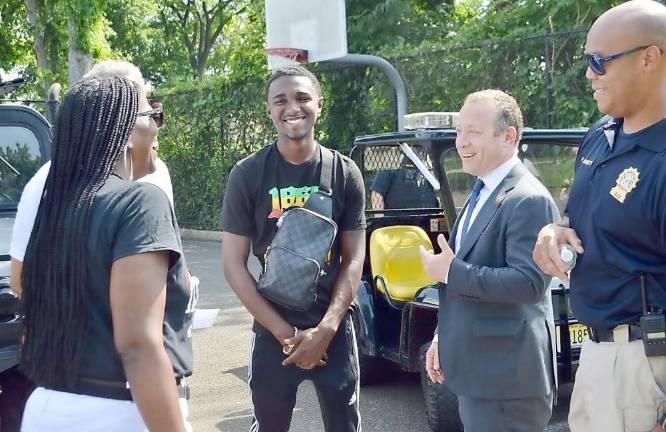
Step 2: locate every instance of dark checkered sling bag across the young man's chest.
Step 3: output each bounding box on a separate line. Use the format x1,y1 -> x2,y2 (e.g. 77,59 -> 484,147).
257,144 -> 338,311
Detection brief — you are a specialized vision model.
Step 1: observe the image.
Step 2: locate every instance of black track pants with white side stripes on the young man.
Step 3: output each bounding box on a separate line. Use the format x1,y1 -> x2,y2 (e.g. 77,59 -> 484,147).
248,314 -> 361,432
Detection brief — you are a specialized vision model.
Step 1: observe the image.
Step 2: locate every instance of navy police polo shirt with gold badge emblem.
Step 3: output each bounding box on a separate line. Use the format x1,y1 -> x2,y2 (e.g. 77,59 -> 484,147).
565,119 -> 666,328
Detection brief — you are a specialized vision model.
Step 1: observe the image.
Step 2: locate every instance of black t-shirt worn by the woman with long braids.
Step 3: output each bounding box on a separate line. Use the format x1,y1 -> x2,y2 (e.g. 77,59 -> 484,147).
73,175 -> 194,388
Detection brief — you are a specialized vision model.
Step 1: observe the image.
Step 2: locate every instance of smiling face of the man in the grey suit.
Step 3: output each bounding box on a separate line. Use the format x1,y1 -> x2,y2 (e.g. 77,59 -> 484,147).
456,99 -> 517,177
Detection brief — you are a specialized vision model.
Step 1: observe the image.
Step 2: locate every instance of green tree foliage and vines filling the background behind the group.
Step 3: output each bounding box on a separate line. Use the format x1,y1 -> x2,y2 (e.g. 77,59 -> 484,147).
0,0 -> 619,228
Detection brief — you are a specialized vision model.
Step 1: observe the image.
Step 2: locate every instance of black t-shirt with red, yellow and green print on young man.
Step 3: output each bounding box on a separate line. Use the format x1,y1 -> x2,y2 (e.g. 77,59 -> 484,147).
220,145 -> 365,327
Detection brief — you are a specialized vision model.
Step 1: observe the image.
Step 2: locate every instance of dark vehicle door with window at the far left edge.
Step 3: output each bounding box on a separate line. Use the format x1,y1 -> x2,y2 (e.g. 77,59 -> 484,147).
0,105 -> 51,276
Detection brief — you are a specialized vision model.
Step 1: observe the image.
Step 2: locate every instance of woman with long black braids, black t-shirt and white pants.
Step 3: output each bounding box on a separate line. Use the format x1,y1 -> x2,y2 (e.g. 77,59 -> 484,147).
22,78 -> 192,432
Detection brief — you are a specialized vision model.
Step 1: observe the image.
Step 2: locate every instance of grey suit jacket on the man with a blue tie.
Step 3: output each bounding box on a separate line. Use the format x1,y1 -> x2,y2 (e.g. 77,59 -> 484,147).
438,163 -> 559,399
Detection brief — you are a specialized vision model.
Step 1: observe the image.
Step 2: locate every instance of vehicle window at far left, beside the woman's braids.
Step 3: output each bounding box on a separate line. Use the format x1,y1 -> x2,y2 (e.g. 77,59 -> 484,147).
0,125 -> 42,208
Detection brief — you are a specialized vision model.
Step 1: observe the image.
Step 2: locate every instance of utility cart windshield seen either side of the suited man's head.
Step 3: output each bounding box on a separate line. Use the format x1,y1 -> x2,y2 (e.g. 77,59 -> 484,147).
441,141 -> 578,214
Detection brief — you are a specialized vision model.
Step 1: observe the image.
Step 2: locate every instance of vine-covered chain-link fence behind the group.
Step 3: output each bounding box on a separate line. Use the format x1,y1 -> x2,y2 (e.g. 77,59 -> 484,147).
160,29 -> 600,229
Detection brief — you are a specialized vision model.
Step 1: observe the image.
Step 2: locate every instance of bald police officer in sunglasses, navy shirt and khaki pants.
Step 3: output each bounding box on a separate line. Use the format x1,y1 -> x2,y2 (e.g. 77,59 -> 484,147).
534,0 -> 666,432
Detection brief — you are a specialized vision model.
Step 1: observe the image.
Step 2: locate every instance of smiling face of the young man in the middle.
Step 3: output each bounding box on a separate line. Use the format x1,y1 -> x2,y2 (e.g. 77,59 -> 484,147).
268,75 -> 323,146
